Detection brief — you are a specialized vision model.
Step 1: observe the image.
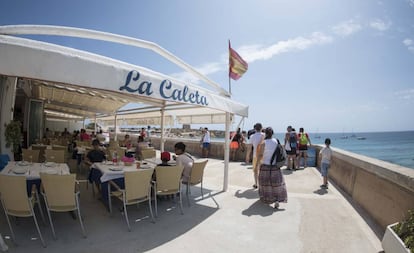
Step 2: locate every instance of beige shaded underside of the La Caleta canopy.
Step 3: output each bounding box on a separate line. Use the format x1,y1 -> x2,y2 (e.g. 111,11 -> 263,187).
17,78 -> 233,125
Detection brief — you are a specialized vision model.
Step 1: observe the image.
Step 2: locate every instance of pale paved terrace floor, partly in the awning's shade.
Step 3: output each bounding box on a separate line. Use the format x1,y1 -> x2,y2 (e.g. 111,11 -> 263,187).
0,155 -> 382,253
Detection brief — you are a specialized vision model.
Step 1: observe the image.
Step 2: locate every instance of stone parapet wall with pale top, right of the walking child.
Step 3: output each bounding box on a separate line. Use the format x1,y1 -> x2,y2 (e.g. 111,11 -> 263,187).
317,144 -> 414,231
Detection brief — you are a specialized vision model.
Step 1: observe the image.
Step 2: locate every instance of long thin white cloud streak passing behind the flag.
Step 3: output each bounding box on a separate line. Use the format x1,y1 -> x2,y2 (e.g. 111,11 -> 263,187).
171,32 -> 333,82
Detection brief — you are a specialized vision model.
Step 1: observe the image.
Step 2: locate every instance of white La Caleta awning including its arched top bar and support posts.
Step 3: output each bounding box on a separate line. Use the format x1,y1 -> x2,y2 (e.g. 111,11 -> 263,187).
0,25 -> 248,191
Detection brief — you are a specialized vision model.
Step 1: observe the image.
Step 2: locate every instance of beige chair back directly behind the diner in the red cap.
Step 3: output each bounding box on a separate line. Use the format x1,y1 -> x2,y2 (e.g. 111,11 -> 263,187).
155,165 -> 184,191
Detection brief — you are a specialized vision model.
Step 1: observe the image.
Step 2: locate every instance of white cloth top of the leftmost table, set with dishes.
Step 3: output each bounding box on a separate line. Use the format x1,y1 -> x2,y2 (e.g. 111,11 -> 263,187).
0,162 -> 70,180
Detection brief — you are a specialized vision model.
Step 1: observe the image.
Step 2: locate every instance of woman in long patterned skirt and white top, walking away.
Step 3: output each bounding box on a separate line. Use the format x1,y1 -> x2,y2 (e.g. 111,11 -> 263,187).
257,127 -> 287,209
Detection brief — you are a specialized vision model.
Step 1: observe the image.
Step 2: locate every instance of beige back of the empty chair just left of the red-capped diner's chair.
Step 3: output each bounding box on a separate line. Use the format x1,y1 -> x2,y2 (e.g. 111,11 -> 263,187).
125,169 -> 154,202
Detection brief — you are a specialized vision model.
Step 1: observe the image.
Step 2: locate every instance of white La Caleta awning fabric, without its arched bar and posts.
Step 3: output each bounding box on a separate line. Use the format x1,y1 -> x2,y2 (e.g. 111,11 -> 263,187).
0,26 -> 248,119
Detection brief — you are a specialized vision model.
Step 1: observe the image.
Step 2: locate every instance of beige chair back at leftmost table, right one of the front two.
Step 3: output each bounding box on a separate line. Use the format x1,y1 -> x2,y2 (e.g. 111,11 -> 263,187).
40,173 -> 76,211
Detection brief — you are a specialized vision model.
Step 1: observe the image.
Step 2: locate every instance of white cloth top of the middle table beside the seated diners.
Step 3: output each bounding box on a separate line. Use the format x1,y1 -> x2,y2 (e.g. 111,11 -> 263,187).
92,162 -> 155,182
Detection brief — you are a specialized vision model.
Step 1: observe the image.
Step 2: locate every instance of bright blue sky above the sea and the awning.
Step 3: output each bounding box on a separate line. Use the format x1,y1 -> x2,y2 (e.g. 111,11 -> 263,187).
0,0 -> 414,132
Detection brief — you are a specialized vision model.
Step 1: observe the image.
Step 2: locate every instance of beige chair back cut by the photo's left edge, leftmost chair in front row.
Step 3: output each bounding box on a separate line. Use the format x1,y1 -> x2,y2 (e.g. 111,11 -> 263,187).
0,174 -> 32,217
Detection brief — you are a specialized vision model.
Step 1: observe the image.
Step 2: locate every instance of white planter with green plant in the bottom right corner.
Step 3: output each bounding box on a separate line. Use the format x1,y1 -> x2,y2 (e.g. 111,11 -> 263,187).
382,210 -> 414,253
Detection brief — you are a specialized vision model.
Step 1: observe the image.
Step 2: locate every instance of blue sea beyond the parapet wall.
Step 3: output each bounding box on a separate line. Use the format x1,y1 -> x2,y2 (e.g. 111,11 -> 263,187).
213,131 -> 414,169
